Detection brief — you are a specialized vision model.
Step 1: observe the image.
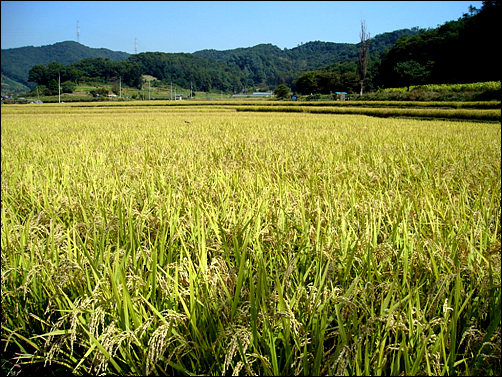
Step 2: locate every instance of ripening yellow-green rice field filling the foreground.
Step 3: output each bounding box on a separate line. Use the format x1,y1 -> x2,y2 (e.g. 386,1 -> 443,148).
1,104 -> 501,375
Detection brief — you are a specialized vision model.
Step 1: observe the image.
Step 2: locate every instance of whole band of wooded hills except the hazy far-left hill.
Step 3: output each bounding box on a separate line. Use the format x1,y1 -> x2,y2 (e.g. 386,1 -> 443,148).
29,1 -> 501,94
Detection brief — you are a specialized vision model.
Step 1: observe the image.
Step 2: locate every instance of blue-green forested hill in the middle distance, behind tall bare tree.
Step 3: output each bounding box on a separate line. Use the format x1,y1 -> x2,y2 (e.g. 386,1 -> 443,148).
113,29 -> 423,93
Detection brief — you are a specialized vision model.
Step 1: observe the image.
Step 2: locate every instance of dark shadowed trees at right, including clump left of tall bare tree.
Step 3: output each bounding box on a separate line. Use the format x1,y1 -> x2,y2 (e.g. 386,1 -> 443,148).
294,1 -> 502,94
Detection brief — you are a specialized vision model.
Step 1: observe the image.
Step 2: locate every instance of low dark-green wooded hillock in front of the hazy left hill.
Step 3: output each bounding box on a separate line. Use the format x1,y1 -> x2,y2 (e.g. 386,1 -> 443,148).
29,52 -> 246,95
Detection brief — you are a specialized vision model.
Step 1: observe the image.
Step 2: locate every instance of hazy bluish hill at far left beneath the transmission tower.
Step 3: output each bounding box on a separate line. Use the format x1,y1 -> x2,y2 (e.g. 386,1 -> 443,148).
2,41 -> 130,87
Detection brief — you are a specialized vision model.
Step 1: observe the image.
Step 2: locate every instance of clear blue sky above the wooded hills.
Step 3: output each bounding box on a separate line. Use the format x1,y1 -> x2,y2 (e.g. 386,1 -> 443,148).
1,1 -> 482,53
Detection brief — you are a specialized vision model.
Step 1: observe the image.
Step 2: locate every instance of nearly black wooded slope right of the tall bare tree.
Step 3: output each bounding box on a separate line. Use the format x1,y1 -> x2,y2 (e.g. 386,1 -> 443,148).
375,1 -> 502,87
